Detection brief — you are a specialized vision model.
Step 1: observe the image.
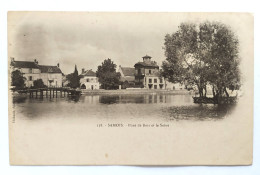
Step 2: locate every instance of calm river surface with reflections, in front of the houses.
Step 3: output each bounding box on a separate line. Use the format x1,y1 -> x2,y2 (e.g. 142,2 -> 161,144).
12,94 -> 236,123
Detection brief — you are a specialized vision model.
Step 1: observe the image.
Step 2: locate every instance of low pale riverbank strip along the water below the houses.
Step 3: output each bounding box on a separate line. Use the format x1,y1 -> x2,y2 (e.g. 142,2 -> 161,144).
81,89 -> 193,95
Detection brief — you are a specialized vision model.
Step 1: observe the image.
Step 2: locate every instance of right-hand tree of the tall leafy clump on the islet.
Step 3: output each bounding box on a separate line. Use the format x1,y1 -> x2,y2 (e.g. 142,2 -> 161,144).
200,22 -> 240,97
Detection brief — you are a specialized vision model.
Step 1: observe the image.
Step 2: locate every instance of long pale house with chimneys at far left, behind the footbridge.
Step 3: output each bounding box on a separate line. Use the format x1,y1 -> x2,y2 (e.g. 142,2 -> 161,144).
11,58 -> 62,87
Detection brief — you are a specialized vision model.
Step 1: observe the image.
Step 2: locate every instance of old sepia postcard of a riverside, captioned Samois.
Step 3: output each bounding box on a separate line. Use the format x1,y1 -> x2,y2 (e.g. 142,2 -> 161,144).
8,12 -> 254,165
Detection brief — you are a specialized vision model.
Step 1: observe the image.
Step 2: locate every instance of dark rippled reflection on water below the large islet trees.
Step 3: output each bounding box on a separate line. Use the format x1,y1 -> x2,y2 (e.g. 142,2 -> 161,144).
163,104 -> 235,120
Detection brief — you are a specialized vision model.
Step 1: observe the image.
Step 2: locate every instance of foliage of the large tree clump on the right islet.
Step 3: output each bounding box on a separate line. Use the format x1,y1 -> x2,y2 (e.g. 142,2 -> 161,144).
162,22 -> 240,97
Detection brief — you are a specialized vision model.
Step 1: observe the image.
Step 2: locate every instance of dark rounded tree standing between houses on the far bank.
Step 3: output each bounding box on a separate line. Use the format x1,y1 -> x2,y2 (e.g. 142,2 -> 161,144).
96,58 -> 121,89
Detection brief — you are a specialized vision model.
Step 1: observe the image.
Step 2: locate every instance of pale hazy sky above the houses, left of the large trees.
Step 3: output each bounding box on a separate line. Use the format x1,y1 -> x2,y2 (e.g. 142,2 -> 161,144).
8,12 -> 248,74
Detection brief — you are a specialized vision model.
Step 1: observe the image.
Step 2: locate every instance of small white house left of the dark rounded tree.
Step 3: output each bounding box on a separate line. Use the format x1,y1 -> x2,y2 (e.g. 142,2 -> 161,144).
80,69 -> 100,90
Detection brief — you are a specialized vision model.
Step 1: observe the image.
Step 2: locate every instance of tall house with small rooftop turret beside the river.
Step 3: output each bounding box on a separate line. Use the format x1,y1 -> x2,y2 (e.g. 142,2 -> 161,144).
134,55 -> 165,89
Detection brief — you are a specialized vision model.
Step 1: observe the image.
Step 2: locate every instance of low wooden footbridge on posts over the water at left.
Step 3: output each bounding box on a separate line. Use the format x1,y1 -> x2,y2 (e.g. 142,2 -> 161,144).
17,87 -> 81,98
